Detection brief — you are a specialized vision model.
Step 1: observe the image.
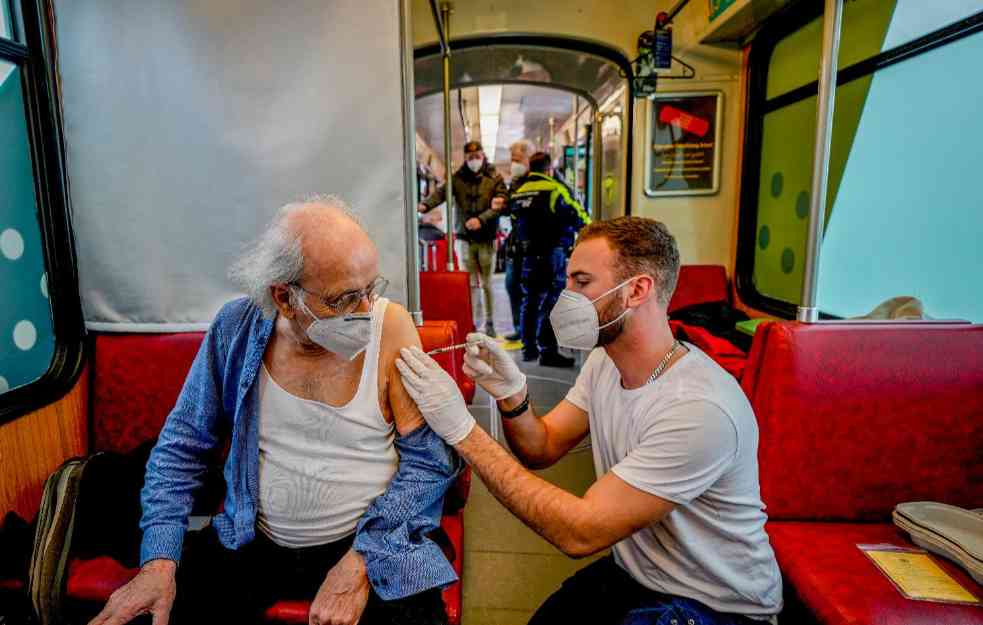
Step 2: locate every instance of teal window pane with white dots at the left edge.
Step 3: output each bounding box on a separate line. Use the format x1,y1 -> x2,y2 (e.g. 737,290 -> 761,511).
0,61 -> 55,393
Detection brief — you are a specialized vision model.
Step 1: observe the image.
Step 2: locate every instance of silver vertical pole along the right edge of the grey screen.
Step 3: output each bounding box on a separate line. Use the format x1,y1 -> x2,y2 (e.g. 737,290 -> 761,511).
399,0 -> 425,326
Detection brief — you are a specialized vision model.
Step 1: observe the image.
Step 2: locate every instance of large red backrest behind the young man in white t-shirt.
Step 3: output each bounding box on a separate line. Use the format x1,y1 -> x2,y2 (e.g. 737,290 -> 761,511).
742,322 -> 983,521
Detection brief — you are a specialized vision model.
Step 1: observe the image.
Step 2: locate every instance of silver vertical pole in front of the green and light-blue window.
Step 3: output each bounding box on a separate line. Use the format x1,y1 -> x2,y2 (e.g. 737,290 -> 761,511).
796,0 -> 843,323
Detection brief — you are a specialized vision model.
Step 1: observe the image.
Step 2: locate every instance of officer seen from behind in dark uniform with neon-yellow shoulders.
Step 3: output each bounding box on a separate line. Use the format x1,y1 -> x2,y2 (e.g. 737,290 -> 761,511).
509,152 -> 590,367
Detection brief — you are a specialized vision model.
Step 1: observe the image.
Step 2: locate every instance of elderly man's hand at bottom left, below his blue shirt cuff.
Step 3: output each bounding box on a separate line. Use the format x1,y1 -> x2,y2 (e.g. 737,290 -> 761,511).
89,560 -> 177,625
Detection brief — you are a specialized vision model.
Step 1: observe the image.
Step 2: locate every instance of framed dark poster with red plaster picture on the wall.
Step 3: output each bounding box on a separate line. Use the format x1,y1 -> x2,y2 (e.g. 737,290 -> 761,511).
645,91 -> 723,197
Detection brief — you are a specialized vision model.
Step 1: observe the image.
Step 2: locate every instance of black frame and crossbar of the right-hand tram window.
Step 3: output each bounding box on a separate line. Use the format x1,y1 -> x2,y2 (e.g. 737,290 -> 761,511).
734,2 -> 983,319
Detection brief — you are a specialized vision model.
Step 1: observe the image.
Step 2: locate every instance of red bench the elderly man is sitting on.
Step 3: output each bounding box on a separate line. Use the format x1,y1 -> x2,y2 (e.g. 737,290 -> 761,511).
73,321 -> 471,625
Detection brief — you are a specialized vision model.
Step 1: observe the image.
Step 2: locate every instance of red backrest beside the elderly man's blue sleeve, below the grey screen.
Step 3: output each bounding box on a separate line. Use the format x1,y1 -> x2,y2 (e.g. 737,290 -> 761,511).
92,332 -> 205,453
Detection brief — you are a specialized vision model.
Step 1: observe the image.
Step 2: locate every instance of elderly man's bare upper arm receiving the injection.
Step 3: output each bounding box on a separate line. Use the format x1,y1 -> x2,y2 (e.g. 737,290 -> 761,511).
379,302 -> 425,436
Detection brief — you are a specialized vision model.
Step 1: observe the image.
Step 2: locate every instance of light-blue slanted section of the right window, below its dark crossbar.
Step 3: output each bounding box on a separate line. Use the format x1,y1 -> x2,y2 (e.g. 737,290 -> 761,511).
818,28 -> 983,322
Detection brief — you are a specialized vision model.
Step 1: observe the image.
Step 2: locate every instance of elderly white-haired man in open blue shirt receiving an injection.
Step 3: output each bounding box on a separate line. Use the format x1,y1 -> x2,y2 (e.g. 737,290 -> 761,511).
91,197 -> 460,625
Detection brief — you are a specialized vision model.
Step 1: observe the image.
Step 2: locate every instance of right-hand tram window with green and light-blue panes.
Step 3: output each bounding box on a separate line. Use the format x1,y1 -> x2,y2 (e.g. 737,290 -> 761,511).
739,0 -> 983,321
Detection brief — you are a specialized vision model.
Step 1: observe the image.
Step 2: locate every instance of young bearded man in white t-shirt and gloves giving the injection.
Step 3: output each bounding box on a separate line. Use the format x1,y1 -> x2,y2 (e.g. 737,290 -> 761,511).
396,217 -> 782,625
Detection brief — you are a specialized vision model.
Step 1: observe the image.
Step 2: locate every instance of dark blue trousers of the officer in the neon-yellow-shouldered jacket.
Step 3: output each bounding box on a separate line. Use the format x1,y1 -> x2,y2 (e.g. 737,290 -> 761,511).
520,247 -> 567,356
